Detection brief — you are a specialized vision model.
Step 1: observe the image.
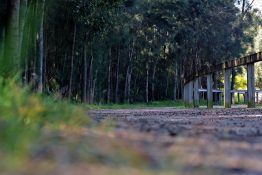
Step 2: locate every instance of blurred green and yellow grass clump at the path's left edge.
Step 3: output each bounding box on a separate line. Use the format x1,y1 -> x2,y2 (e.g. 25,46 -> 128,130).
0,78 -> 89,169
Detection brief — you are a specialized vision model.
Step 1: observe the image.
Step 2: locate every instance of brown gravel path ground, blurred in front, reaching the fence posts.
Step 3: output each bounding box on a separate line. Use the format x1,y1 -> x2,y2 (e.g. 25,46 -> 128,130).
5,108 -> 262,175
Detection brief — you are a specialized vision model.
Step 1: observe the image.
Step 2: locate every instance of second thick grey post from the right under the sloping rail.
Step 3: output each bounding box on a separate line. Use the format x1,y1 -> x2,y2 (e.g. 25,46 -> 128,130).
224,69 -> 231,108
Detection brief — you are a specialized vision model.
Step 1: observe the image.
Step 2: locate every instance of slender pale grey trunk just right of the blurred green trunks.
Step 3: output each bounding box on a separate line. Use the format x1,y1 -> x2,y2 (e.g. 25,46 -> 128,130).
37,0 -> 45,93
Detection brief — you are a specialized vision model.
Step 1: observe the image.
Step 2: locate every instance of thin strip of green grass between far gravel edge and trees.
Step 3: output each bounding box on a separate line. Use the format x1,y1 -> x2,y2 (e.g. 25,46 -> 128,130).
86,100 -> 185,109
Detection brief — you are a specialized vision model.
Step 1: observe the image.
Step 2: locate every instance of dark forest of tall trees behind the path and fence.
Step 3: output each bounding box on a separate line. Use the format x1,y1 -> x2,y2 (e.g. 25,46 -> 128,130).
0,0 -> 259,103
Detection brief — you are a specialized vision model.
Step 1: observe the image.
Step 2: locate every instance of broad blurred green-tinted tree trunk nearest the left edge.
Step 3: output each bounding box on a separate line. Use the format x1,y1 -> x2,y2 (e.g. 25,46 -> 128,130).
2,0 -> 20,76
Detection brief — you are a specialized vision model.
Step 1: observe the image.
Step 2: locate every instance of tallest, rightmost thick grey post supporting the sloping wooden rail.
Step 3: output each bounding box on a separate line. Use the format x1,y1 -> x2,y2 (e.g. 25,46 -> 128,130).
247,63 -> 256,108
